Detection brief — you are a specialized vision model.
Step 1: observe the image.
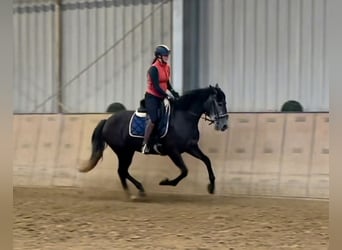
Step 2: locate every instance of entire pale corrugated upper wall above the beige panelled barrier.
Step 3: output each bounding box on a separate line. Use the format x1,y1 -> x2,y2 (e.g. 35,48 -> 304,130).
13,0 -> 329,113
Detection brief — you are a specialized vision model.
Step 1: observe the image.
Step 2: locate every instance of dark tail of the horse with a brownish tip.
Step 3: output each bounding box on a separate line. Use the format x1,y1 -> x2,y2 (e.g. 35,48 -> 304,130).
78,120 -> 107,173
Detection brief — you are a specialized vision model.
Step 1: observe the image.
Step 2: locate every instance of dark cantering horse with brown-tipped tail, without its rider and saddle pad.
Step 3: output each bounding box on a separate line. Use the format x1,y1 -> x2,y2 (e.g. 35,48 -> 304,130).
79,84 -> 229,198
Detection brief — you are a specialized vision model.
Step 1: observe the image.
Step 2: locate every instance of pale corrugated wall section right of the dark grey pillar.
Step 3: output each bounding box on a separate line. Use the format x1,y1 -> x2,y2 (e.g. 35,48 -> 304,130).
194,0 -> 329,112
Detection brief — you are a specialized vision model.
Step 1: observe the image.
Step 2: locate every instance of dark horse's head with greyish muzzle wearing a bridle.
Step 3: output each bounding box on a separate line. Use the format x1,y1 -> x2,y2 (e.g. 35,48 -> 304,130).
204,84 -> 229,131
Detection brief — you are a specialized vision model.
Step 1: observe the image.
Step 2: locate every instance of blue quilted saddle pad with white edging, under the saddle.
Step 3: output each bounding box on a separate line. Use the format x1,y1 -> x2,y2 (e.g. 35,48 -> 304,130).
128,100 -> 170,138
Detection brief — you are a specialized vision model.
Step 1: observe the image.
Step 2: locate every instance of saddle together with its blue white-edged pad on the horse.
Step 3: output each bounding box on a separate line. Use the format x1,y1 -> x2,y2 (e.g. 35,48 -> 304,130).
128,99 -> 171,140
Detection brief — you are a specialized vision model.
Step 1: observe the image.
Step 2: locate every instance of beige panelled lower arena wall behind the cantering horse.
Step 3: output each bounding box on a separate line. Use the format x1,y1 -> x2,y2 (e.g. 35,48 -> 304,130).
13,113 -> 329,199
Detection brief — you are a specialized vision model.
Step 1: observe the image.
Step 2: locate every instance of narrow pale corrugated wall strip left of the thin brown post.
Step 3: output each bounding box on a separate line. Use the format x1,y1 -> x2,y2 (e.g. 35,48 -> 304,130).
13,1 -> 57,112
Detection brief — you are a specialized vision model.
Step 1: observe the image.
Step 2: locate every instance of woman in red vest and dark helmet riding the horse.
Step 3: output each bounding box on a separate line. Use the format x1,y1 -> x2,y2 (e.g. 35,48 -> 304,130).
141,45 -> 179,154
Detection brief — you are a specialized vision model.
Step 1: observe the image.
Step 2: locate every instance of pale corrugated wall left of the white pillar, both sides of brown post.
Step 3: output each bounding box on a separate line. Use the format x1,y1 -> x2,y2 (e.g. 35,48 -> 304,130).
13,0 -> 172,113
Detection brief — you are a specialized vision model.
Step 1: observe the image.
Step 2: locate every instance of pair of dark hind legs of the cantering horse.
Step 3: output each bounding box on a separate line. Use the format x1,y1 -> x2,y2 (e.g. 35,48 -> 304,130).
117,151 -> 145,197
